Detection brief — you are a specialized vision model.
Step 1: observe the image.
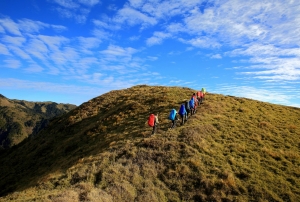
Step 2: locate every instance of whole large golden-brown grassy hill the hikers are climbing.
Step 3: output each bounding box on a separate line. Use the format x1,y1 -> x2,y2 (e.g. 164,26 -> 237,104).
0,86 -> 300,201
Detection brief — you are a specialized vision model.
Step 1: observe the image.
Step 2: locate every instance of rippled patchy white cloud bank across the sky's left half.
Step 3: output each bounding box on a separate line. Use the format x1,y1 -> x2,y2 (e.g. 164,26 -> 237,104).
0,16 -> 164,89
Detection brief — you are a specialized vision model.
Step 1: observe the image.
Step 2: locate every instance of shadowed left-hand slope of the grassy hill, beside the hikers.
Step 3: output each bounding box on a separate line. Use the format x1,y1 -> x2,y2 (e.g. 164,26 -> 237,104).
0,86 -> 192,197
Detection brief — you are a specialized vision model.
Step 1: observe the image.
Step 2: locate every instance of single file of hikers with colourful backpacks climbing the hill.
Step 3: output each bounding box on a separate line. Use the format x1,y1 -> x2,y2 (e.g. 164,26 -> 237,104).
148,88 -> 206,134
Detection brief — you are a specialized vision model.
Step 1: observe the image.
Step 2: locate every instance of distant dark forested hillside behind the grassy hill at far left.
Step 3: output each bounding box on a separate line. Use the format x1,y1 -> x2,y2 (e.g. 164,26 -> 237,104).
0,94 -> 76,149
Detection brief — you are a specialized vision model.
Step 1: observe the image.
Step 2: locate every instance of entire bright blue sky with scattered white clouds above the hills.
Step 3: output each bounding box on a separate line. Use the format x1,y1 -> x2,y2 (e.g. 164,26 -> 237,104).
0,0 -> 300,107
